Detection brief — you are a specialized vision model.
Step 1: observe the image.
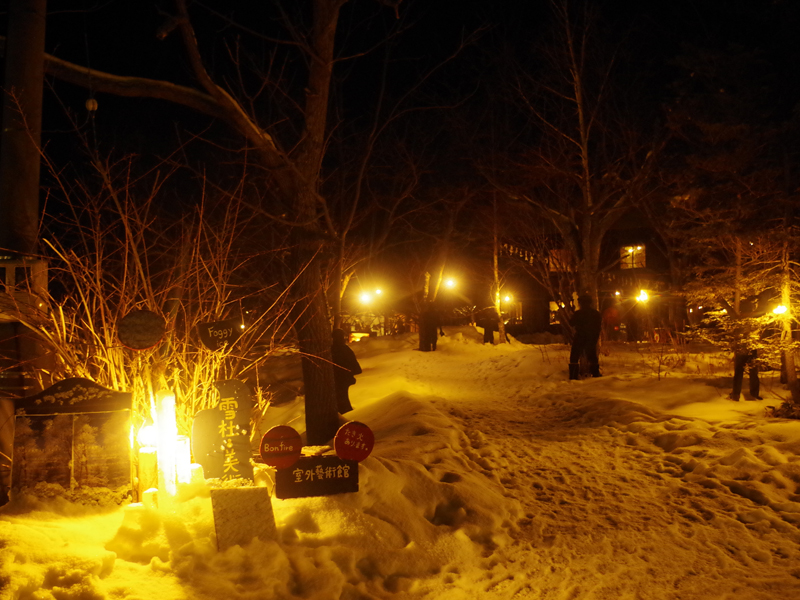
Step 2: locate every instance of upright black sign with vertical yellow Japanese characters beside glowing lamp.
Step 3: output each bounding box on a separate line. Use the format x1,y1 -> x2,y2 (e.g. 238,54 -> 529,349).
192,379 -> 253,480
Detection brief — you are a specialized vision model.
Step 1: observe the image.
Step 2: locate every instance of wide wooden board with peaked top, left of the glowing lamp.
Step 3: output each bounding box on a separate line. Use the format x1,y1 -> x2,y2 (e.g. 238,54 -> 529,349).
12,378 -> 131,493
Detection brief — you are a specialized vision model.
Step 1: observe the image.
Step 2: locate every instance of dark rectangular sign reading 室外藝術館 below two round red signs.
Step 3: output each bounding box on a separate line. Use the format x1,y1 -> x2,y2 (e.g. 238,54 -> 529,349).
275,455 -> 358,499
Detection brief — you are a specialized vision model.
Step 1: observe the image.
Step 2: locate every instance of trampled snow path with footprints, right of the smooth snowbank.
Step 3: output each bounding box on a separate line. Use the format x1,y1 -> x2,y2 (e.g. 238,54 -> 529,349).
354,330 -> 800,600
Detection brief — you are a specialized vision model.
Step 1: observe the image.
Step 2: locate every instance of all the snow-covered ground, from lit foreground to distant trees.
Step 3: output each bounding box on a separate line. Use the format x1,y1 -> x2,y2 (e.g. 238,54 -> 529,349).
0,327 -> 800,600
